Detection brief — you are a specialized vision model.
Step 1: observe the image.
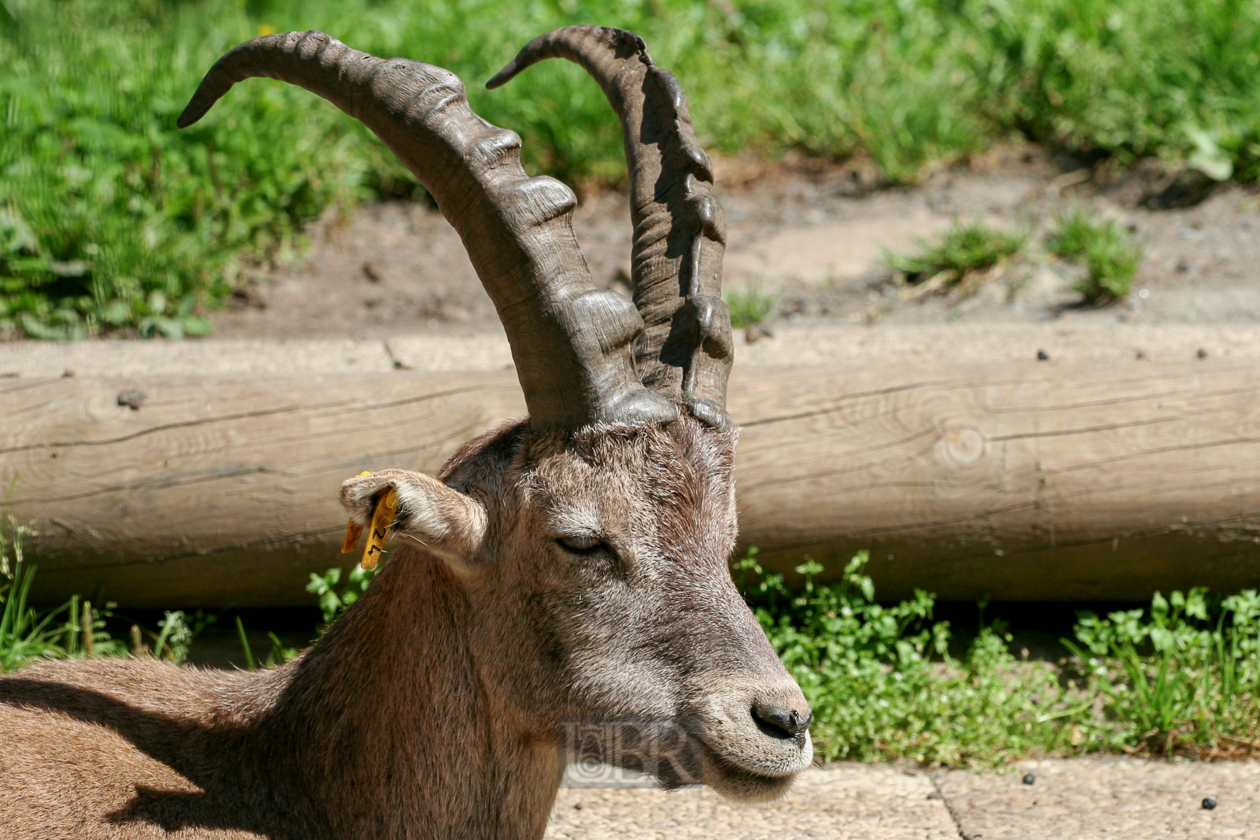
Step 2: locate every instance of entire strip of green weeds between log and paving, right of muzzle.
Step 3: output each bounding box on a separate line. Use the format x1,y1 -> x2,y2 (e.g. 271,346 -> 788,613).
736,553 -> 1260,764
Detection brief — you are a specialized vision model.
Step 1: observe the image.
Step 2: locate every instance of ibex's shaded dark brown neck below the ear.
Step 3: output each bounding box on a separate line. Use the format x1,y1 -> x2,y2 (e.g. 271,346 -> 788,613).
250,553 -> 558,839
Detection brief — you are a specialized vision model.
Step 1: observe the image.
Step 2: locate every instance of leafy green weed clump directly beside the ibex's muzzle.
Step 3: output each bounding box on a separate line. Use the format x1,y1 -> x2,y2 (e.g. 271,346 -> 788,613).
740,553 -> 1065,764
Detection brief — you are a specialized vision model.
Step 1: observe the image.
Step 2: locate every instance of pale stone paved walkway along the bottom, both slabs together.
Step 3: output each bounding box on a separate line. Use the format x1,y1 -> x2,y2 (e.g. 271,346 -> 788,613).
547,758 -> 1260,840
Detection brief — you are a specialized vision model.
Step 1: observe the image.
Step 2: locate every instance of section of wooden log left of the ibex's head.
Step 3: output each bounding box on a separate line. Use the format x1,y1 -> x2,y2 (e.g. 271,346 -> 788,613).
0,372 -> 524,607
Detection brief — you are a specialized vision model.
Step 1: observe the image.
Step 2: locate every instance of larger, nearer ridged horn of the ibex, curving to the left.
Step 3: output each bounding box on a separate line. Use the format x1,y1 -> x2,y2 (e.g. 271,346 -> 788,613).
178,31 -> 677,428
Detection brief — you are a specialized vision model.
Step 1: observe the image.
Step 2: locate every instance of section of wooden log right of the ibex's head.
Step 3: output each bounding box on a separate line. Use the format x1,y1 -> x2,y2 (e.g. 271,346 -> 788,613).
735,361 -> 1260,599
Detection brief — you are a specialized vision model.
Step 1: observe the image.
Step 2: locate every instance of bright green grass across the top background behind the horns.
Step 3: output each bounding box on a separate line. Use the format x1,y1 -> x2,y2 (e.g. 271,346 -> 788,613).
0,0 -> 1260,338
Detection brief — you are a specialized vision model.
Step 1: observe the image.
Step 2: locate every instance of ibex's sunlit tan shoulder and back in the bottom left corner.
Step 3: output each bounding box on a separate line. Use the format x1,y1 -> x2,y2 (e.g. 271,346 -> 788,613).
0,657 -> 273,840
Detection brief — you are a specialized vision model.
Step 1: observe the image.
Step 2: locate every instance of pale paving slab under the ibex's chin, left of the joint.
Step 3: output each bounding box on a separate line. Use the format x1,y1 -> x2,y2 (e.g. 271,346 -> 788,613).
547,764 -> 958,840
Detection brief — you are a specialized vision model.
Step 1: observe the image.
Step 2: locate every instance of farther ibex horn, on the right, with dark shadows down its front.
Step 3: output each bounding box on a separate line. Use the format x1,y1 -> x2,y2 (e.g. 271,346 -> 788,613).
486,26 -> 733,426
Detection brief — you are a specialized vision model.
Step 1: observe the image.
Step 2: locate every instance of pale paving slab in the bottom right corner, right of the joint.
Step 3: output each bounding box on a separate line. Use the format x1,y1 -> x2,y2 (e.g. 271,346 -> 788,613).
936,758 -> 1260,840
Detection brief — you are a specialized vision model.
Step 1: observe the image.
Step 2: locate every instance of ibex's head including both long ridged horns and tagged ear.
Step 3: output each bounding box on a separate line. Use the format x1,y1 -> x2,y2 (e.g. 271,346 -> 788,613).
180,26 -> 811,798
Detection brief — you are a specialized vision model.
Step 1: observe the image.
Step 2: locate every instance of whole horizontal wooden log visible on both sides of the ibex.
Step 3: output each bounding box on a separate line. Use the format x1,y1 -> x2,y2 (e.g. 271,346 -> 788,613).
0,361 -> 1260,607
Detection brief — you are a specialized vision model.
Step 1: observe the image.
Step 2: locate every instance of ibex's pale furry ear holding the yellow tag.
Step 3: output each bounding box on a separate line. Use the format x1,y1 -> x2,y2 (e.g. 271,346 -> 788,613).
341,470 -> 486,573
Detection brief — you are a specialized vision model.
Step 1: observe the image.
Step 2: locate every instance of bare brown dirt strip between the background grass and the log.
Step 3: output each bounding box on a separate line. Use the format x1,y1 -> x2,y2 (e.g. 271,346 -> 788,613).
213,149 -> 1260,339
